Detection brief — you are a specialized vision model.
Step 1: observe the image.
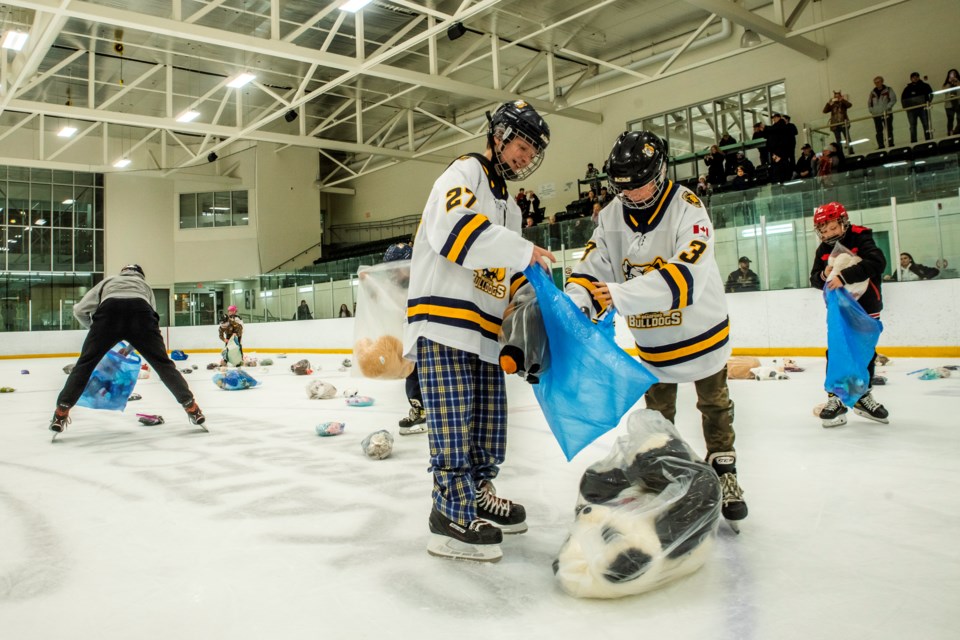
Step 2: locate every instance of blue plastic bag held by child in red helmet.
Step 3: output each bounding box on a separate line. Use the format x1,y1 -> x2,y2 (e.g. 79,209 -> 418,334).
823,287 -> 883,406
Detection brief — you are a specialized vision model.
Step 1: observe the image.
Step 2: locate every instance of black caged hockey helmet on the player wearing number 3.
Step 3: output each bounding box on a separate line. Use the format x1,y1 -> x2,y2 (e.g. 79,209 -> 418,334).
604,131 -> 667,209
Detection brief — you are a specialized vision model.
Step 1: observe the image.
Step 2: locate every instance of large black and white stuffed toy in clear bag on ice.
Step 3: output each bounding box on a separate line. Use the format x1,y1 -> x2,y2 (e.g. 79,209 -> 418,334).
553,409 -> 721,598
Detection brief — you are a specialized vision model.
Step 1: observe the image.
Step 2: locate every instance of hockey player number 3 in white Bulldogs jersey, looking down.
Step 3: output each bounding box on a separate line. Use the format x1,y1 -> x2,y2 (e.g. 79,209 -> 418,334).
565,131 -> 747,521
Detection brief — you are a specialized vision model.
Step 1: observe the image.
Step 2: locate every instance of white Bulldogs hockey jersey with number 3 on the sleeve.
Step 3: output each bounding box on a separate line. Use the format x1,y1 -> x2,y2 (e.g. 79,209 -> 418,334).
565,182 -> 731,382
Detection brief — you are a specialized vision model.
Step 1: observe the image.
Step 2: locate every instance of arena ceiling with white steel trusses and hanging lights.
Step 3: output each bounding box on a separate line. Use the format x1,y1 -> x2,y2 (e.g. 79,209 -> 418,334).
0,0 -> 908,192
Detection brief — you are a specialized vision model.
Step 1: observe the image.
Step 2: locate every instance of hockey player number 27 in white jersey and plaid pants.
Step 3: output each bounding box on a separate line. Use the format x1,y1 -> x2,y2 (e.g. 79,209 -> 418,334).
404,101 -> 555,562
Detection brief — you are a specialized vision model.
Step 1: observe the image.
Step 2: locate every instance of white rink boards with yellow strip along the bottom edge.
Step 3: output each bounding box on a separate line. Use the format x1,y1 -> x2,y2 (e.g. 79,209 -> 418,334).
0,279 -> 960,357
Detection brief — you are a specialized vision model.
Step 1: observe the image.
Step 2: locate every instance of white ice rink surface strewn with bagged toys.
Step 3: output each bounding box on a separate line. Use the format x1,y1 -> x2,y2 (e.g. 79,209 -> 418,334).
0,353 -> 960,640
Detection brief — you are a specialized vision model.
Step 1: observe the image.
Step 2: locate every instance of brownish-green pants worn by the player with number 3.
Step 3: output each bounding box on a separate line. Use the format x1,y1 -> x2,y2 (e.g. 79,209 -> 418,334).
643,367 -> 736,455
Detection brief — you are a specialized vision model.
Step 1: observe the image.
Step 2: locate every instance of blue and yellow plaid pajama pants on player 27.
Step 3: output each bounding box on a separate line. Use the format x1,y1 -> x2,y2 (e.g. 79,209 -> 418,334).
417,338 -> 507,525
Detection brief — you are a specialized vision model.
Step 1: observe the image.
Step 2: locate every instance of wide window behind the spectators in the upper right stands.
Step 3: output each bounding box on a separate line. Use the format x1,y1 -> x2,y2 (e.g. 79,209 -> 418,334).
627,81 -> 787,180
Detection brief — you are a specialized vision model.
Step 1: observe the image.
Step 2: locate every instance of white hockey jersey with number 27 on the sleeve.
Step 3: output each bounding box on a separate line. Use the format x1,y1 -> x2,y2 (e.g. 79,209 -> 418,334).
403,154 -> 533,364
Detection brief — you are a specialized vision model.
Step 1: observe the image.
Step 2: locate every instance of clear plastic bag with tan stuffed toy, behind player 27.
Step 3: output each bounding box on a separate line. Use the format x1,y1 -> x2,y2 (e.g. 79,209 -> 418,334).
353,260 -> 413,379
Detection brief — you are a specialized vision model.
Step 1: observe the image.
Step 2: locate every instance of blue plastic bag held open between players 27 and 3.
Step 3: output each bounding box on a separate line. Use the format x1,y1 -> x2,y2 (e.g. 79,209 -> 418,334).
524,265 -> 657,460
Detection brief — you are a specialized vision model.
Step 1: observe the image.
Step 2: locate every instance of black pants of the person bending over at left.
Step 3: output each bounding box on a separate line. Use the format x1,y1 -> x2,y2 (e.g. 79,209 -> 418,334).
57,298 -> 193,407
